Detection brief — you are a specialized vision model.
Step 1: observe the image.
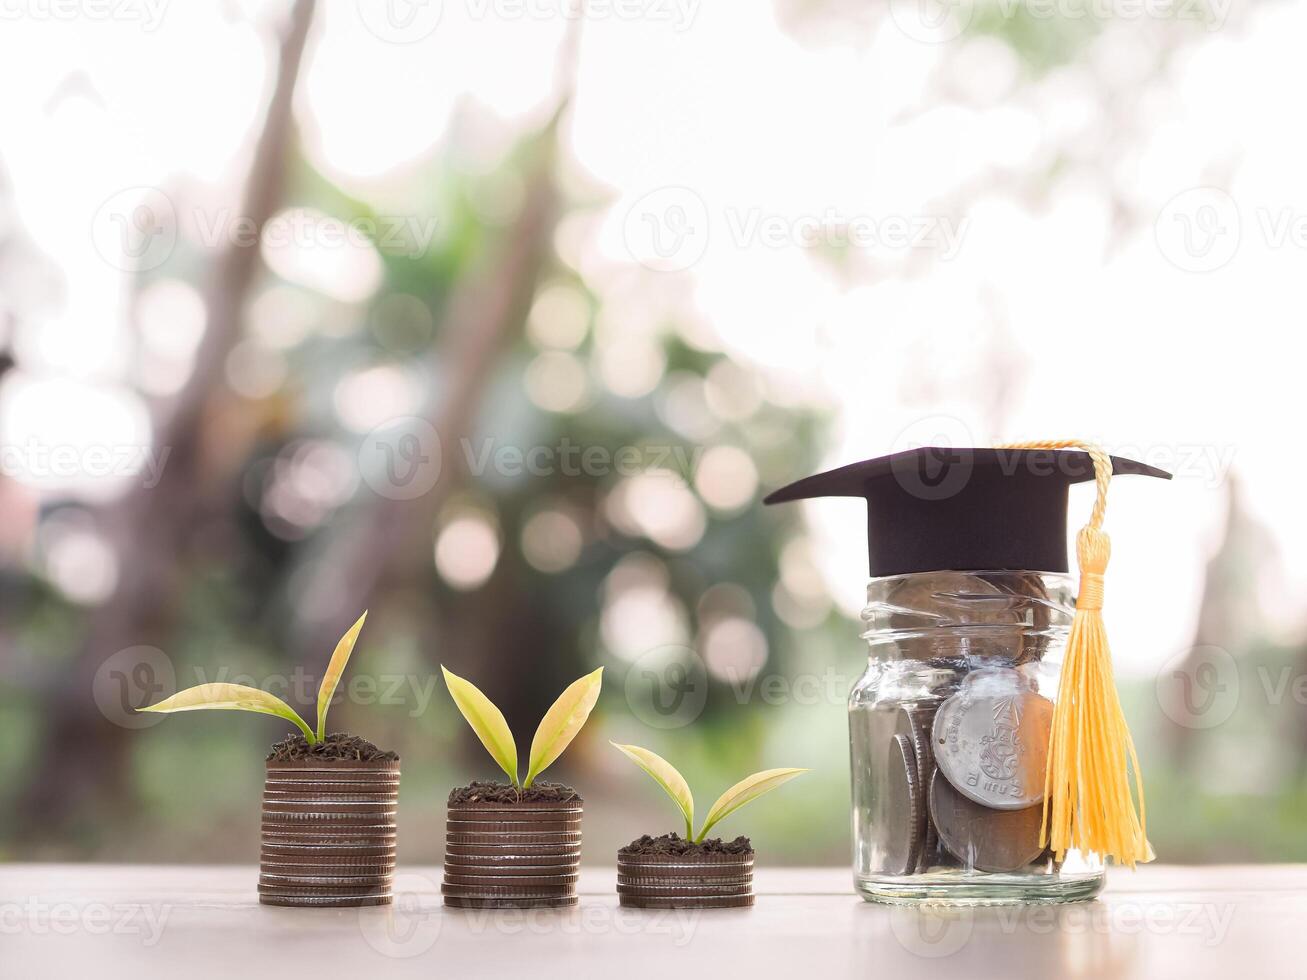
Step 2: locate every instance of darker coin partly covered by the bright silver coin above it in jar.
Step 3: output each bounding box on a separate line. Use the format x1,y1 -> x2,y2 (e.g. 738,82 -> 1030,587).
929,772 -> 1044,872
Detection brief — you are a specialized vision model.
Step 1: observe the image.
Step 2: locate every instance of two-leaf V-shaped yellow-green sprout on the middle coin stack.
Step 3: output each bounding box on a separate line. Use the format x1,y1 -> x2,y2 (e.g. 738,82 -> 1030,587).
440,665 -> 604,789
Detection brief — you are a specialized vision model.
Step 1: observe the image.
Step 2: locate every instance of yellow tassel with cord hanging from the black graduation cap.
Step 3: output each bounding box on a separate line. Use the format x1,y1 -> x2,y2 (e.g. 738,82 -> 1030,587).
1000,440 -> 1154,868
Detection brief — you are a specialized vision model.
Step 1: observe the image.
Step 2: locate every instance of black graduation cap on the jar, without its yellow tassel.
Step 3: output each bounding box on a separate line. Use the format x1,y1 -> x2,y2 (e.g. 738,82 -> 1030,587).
765,447 -> 1171,576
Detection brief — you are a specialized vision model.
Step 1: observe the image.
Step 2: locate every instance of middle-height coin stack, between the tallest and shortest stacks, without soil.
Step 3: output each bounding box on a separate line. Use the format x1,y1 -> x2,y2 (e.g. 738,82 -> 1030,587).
440,800 -> 583,908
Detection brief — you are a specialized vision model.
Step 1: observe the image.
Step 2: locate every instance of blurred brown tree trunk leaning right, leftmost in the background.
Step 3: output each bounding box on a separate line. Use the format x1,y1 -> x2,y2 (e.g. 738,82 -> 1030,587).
18,0 -> 315,840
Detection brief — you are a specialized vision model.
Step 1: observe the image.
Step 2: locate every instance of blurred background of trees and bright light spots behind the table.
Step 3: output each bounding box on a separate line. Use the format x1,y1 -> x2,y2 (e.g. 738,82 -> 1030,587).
0,0 -> 1307,864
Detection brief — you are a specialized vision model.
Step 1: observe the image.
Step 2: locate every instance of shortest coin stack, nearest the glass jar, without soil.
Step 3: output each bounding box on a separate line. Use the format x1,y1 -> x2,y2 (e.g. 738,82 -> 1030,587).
617,851 -> 753,908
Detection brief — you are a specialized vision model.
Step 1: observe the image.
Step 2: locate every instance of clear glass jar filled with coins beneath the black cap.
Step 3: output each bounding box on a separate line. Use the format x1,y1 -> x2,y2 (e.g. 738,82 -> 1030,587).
848,571 -> 1103,906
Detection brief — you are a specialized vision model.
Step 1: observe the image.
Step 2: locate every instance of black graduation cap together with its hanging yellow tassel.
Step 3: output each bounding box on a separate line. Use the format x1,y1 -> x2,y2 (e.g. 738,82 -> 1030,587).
765,439 -> 1171,868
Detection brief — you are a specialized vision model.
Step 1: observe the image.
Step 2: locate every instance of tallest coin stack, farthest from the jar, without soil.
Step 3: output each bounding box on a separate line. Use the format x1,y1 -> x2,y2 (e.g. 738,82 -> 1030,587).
259,759 -> 400,908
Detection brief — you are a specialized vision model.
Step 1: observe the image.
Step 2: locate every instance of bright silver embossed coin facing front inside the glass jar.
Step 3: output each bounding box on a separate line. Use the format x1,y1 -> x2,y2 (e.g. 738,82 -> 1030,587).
933,668 -> 1053,810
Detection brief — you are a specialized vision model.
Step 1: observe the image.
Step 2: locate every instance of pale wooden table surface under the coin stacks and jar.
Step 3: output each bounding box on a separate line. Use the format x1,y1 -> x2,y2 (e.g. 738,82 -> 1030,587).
0,865 -> 1307,980
